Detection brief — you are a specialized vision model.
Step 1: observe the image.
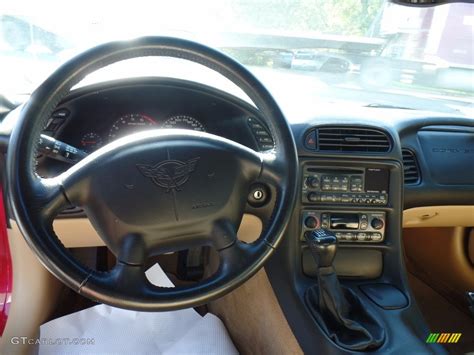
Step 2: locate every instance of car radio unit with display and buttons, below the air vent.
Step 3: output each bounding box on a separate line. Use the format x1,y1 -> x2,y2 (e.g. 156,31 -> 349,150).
302,166 -> 389,206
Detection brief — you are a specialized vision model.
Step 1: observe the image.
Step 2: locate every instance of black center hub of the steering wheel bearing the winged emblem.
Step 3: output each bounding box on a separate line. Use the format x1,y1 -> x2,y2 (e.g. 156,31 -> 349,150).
61,130 -> 262,262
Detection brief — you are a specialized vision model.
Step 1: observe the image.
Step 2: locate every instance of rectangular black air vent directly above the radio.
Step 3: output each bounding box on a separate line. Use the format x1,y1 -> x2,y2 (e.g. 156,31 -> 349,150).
316,127 -> 392,153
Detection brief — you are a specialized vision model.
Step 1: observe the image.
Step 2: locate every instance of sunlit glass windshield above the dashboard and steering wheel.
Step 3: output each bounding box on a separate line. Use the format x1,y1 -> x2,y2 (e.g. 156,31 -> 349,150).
0,0 -> 474,116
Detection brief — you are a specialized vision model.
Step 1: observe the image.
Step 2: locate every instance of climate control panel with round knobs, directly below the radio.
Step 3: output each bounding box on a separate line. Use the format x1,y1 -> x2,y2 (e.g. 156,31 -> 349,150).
301,210 -> 386,243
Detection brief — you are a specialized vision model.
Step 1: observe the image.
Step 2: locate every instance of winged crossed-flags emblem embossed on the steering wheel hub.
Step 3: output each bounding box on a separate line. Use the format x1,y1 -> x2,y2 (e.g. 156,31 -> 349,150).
137,157 -> 199,192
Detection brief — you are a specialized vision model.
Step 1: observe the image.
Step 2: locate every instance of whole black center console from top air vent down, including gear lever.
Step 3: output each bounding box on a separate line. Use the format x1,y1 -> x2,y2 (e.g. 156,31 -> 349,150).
265,124 -> 442,354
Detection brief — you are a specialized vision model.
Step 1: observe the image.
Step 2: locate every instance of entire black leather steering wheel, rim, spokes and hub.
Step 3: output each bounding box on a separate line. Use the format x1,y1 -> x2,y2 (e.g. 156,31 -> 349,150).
7,37 -> 298,311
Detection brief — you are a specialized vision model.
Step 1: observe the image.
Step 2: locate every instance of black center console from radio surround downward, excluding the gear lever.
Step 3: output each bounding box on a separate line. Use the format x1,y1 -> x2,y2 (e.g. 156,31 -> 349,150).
267,152 -> 442,354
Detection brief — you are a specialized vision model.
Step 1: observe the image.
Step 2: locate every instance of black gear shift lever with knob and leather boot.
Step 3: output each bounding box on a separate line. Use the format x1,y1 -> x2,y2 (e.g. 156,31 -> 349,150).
305,229 -> 385,351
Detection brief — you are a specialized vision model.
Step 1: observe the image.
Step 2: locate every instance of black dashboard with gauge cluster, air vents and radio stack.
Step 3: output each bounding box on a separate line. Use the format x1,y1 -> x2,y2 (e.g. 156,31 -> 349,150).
21,78 -> 474,248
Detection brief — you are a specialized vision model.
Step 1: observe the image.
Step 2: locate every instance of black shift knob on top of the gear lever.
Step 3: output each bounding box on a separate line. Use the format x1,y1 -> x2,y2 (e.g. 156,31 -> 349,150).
305,229 -> 337,269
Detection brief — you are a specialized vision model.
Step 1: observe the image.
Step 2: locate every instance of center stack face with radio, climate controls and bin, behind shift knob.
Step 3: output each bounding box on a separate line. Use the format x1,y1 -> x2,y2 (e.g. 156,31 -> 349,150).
298,160 -> 394,279
